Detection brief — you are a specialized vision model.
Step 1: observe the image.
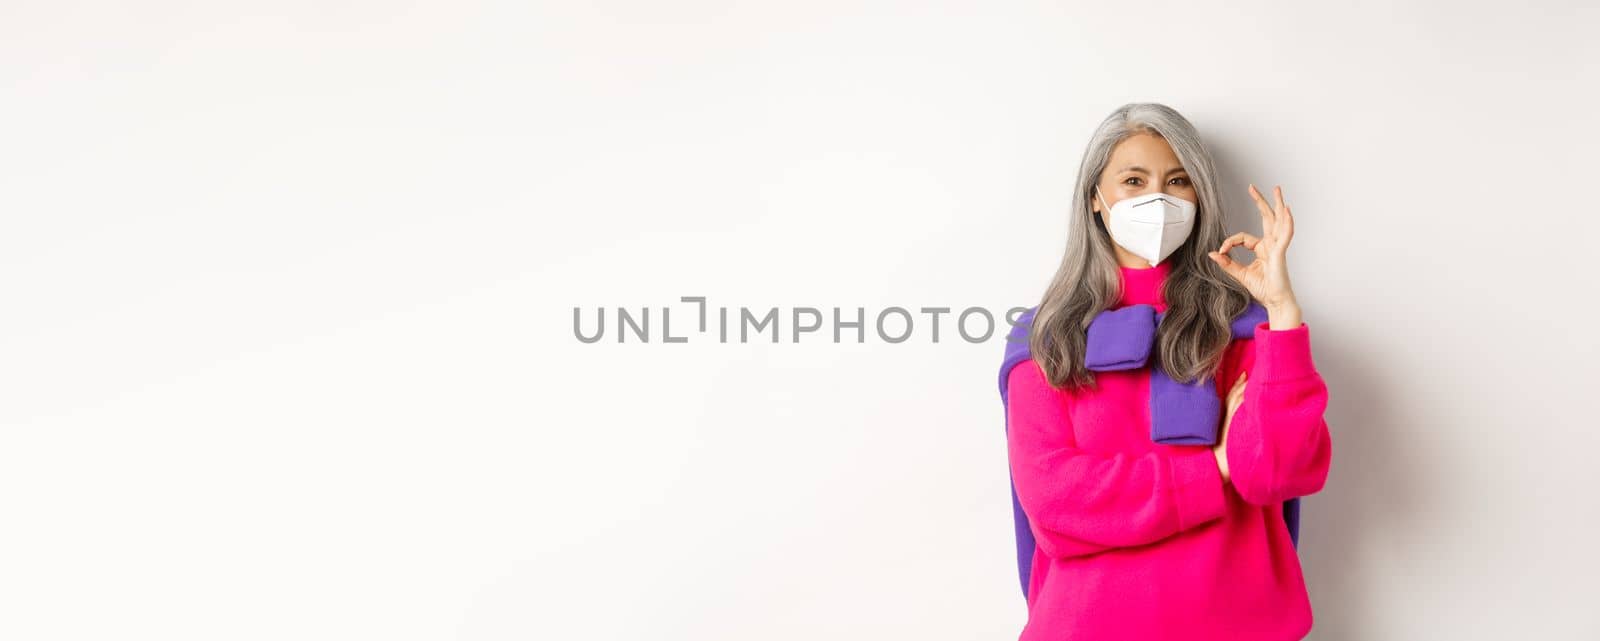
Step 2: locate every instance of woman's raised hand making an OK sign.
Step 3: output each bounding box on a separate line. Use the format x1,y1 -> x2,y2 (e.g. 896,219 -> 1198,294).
1206,185 -> 1296,310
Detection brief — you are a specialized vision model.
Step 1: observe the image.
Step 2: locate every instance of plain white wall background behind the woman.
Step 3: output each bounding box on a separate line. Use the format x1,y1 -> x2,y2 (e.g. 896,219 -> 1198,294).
0,0 -> 1600,641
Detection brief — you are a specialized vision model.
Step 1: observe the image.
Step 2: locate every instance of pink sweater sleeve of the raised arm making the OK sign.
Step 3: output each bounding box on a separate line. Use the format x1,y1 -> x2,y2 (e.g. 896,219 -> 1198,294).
1221,323 -> 1333,505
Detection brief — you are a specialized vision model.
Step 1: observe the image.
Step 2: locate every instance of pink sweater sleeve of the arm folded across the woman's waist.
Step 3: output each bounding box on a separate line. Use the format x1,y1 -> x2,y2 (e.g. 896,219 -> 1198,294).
1006,360 -> 1227,558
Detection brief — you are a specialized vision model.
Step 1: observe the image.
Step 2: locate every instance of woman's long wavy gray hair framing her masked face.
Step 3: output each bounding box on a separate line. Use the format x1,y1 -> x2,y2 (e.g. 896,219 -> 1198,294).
1029,102 -> 1250,388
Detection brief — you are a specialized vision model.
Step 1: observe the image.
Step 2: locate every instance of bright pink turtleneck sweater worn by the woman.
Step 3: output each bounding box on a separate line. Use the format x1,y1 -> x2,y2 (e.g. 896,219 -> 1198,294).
1006,262 -> 1331,641
